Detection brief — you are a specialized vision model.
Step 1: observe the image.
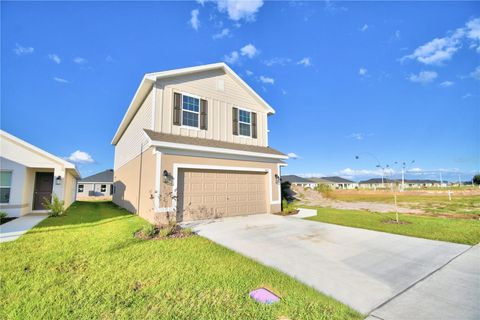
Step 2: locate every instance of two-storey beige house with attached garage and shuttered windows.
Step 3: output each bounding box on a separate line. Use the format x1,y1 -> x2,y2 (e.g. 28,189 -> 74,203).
112,63 -> 288,222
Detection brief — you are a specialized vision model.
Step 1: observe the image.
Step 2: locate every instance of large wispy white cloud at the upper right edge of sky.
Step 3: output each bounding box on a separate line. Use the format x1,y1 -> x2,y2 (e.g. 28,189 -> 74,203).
400,18 -> 480,65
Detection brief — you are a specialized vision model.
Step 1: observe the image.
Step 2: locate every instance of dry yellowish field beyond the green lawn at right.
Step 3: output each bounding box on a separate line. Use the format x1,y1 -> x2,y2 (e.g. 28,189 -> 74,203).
329,192 -> 480,216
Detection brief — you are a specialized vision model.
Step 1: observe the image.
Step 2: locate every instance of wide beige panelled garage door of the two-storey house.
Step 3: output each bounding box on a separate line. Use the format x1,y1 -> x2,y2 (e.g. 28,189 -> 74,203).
177,169 -> 267,221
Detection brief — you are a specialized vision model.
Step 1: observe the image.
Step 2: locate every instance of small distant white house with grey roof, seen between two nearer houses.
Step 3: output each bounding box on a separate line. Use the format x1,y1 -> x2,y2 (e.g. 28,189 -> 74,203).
77,169 -> 113,200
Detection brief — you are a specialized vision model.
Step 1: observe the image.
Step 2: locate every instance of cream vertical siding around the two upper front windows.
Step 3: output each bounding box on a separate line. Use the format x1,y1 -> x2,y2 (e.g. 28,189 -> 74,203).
158,70 -> 268,146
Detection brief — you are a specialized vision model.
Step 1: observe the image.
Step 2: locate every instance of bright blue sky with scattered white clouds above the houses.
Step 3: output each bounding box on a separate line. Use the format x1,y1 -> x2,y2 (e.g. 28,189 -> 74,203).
0,0 -> 480,180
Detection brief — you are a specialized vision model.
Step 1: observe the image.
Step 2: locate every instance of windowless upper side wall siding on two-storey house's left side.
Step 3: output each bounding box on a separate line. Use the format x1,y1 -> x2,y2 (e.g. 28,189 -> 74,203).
114,91 -> 153,170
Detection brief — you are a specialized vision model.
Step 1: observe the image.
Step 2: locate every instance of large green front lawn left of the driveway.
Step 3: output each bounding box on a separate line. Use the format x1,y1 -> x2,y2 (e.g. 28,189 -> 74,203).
0,202 -> 363,319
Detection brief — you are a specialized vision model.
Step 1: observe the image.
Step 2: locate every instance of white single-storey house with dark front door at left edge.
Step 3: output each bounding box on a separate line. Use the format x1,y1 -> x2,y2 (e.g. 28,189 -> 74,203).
0,130 -> 80,217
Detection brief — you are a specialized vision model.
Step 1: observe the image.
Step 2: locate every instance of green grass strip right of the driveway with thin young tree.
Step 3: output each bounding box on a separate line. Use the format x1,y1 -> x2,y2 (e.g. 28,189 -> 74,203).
307,208 -> 480,245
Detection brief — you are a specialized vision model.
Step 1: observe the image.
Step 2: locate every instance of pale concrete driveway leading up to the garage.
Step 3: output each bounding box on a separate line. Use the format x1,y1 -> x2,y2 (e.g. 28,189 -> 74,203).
186,210 -> 479,319
